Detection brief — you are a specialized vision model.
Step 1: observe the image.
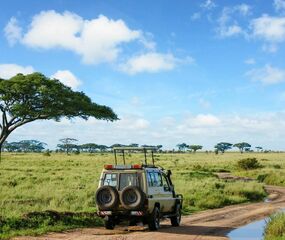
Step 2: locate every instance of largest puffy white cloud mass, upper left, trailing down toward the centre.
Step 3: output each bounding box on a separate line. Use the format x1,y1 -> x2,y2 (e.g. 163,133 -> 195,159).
6,10 -> 185,74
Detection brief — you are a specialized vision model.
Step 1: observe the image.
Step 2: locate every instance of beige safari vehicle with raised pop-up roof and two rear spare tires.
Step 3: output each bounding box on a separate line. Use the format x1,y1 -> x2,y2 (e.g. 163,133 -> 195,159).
96,147 -> 183,230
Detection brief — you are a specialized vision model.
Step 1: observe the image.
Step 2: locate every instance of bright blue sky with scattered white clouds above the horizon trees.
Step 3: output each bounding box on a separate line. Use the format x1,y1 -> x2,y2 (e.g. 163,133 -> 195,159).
0,0 -> 285,150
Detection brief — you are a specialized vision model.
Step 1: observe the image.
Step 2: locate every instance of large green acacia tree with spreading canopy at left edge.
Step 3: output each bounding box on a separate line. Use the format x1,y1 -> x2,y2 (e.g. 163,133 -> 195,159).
0,73 -> 118,160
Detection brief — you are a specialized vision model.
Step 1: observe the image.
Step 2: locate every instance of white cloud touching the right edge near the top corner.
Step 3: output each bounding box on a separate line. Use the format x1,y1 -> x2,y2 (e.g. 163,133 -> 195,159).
250,14 -> 285,43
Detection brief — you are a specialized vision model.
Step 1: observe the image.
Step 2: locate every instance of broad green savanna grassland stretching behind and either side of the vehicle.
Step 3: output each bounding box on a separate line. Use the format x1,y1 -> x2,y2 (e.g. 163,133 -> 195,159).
0,153 -> 285,238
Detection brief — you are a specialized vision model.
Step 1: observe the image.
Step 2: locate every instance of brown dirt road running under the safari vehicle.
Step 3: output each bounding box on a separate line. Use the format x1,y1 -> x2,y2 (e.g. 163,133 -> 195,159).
17,176 -> 285,240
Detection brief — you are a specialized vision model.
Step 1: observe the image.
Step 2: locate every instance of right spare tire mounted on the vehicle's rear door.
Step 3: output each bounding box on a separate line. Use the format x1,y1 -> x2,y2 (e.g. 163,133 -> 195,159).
120,186 -> 145,210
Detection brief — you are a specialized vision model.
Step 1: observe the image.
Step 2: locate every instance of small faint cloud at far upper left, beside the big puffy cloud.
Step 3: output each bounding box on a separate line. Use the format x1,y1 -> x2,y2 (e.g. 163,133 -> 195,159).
4,17 -> 22,46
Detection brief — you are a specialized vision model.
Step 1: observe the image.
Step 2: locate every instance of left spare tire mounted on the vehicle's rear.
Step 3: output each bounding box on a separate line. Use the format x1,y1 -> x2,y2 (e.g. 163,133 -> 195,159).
95,186 -> 119,210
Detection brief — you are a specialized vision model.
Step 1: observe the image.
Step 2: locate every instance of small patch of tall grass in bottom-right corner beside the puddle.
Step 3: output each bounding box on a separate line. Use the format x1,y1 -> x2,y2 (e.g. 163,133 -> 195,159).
264,213 -> 285,240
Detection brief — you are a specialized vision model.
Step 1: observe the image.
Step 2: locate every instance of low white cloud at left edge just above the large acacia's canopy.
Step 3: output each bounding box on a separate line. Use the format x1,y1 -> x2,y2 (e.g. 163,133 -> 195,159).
0,64 -> 35,79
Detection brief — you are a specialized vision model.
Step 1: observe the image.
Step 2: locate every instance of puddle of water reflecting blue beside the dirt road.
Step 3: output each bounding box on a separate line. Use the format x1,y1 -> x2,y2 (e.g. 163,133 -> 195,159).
228,219 -> 266,240
